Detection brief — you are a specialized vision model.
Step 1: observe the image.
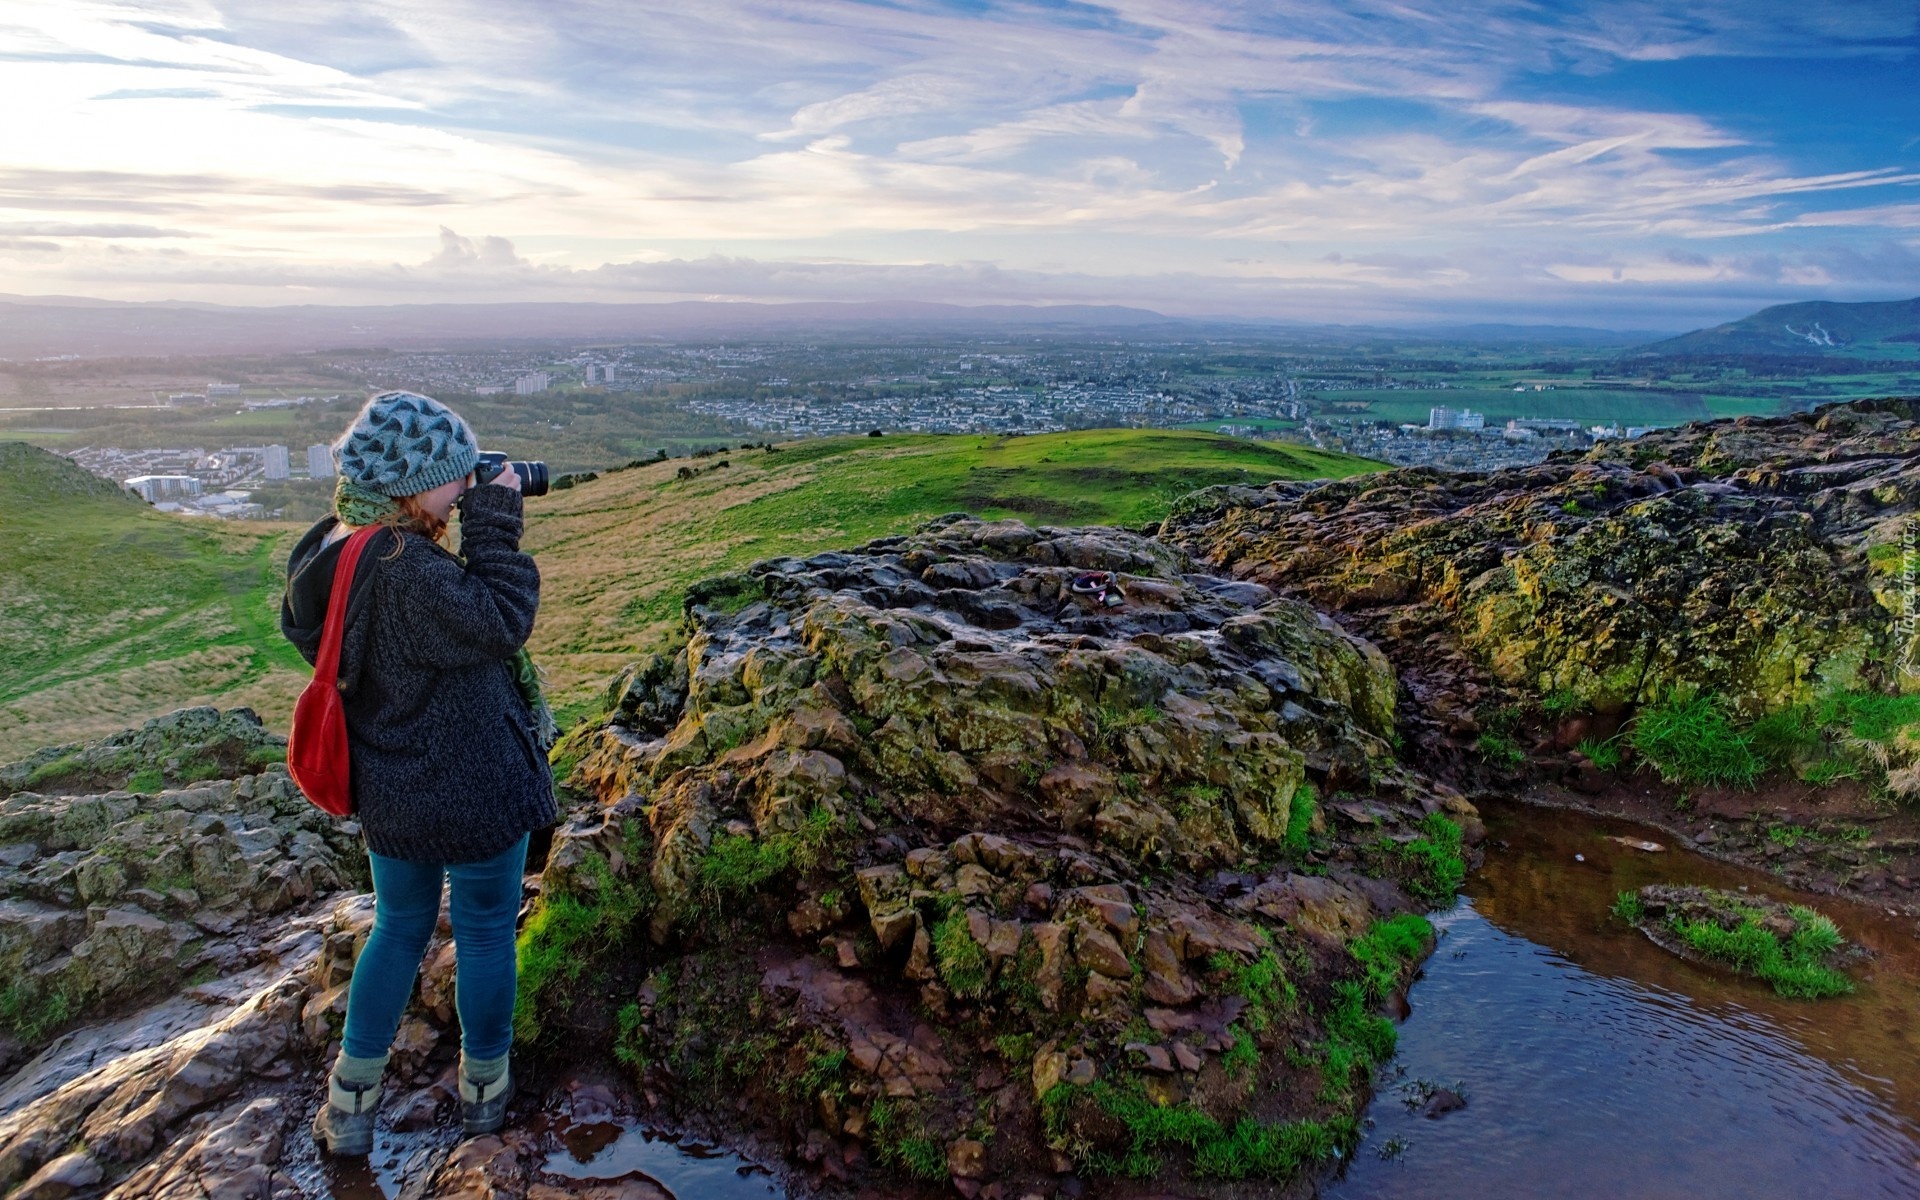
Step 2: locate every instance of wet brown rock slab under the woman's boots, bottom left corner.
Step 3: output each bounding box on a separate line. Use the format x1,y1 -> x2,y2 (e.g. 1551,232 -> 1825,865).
0,871 -> 495,1200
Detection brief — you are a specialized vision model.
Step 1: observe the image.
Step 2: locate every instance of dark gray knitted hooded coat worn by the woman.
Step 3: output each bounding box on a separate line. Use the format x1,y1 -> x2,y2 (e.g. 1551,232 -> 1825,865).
280,484 -> 555,862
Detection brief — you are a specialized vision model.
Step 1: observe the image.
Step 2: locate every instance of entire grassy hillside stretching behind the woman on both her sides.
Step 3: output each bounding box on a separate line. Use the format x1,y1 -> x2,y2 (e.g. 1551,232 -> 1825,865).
0,430 -> 1379,748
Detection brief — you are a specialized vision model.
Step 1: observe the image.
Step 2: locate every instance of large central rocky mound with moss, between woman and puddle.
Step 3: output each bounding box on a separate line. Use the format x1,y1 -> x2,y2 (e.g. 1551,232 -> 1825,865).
560,516 -> 1476,1196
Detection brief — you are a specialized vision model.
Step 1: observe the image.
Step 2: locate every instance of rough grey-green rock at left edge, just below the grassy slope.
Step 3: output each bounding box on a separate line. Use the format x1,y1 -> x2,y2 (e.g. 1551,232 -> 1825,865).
0,710 -> 367,1060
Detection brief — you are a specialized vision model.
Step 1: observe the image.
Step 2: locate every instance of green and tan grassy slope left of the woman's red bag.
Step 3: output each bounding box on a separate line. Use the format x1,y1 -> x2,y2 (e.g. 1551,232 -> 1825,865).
0,442 -> 305,758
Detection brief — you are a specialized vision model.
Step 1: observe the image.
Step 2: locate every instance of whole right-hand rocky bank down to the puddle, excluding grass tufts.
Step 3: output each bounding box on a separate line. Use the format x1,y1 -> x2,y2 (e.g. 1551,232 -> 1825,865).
1162,399 -> 1920,906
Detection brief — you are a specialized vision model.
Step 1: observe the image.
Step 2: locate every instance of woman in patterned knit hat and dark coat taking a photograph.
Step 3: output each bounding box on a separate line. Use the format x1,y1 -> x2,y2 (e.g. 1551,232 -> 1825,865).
280,392 -> 555,1154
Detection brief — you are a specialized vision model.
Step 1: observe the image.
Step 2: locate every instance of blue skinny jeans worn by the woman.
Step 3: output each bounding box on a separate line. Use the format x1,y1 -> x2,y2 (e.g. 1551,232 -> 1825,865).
344,835 -> 526,1058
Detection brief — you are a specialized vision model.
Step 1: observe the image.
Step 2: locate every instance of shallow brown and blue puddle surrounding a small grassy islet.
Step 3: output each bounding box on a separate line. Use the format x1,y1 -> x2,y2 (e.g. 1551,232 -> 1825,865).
1327,794 -> 1920,1200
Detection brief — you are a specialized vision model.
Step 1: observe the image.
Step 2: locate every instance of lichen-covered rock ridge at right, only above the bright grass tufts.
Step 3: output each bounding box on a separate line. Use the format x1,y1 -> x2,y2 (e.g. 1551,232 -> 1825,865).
1162,401 -> 1920,783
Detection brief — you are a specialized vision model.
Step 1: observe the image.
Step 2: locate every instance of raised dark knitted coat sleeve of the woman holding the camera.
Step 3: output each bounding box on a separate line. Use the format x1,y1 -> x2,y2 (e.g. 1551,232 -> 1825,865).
382,484 -> 540,670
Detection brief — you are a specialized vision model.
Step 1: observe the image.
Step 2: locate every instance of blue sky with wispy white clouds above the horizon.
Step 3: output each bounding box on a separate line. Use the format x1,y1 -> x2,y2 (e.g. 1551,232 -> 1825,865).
0,0 -> 1920,330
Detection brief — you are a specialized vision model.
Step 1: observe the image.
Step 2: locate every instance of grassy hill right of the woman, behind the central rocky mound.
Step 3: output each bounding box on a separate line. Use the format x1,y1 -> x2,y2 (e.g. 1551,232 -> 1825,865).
526,430 -> 1380,721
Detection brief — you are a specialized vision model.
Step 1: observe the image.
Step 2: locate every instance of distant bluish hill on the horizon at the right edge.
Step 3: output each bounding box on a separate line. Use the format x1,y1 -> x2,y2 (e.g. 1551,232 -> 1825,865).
1636,298 -> 1920,359
